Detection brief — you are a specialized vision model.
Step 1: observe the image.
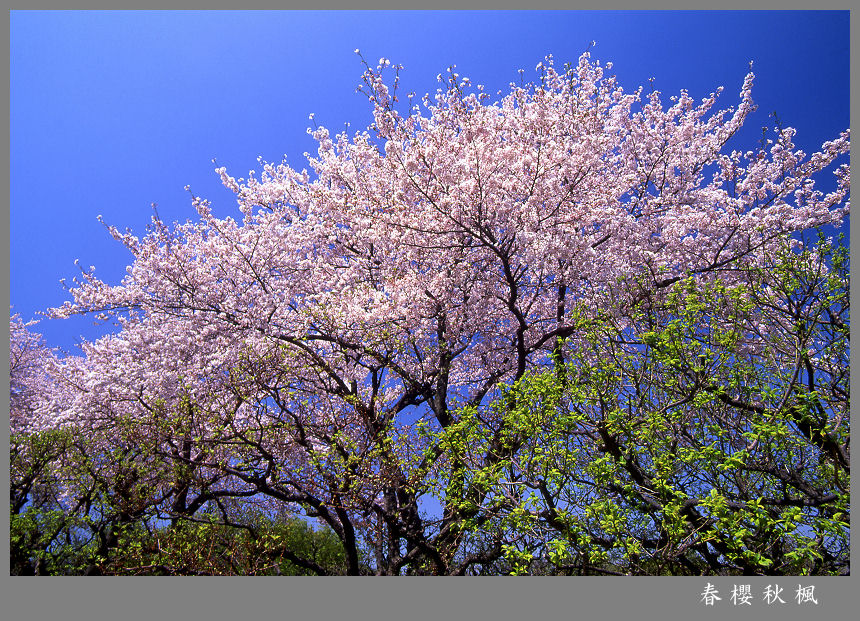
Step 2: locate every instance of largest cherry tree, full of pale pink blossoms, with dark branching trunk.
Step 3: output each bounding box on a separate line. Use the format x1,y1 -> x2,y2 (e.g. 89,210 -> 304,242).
28,53 -> 850,574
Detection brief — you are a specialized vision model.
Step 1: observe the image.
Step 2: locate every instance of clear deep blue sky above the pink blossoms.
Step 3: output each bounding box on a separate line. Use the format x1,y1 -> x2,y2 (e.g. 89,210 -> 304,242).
10,11 -> 849,350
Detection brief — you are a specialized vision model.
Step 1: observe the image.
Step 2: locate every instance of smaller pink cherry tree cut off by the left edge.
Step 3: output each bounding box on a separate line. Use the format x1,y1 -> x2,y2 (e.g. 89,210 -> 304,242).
10,315 -> 260,573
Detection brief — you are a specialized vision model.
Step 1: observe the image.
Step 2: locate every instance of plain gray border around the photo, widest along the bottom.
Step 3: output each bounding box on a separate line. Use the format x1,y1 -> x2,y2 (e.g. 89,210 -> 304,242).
0,0 -> 860,621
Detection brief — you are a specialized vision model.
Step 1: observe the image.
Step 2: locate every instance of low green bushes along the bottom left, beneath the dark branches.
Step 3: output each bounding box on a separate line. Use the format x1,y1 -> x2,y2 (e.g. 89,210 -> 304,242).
10,496 -> 345,576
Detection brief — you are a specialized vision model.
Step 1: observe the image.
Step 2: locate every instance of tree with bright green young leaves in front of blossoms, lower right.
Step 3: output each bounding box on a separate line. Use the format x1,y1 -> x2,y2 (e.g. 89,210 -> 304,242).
440,235 -> 850,575
